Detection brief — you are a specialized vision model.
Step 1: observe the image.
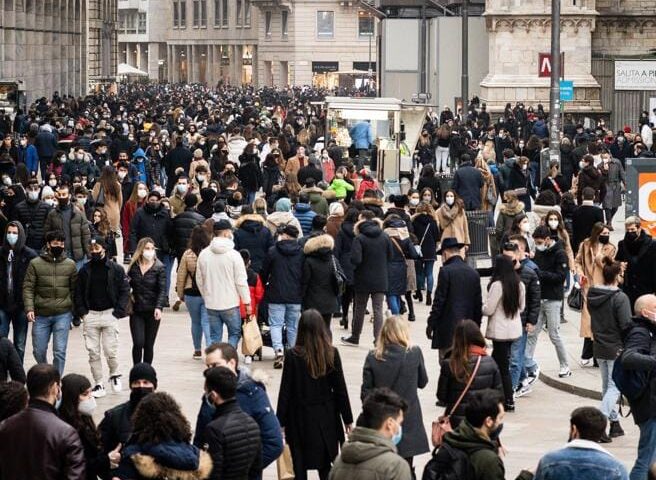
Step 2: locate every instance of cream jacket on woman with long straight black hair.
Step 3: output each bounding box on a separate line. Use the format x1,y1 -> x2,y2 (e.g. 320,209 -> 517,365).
483,280 -> 526,341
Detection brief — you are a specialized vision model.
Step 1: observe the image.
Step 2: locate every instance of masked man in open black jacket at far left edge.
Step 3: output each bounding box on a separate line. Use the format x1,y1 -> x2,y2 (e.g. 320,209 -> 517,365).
0,221 -> 37,363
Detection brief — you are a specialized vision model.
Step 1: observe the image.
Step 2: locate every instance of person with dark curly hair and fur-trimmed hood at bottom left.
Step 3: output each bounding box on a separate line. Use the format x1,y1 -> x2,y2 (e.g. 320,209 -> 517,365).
111,392 -> 211,480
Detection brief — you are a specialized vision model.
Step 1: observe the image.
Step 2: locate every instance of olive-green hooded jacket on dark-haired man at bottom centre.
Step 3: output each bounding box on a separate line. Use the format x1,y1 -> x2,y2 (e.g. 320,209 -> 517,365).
328,427 -> 412,480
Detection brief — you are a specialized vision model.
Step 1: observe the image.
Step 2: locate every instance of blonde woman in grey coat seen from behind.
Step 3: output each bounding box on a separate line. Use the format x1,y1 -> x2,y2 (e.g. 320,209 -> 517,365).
360,316 -> 429,470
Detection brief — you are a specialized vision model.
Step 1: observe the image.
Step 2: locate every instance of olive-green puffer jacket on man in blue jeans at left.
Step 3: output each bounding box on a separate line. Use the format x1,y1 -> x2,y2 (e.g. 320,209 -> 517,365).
23,252 -> 77,317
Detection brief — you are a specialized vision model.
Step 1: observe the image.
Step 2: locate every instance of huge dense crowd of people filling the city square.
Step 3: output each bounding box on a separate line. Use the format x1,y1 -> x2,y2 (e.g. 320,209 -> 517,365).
0,85 -> 656,480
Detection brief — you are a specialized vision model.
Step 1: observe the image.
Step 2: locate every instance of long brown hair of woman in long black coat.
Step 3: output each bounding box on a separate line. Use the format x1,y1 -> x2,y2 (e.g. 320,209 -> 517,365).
294,308 -> 335,379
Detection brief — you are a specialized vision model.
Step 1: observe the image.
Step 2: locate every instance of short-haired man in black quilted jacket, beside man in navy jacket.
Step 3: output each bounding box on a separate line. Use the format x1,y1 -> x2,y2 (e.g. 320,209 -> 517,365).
204,367 -> 260,480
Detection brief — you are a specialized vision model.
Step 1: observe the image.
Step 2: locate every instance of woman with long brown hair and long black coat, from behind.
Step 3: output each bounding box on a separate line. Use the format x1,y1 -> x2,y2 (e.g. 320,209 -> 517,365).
276,310 -> 353,480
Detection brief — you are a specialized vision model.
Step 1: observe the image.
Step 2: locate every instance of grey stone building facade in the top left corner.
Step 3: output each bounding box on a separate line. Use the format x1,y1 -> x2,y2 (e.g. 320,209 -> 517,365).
0,0 -> 117,103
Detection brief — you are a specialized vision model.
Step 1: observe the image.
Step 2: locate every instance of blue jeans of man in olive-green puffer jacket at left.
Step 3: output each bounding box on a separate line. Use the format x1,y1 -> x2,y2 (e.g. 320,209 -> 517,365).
32,312 -> 72,375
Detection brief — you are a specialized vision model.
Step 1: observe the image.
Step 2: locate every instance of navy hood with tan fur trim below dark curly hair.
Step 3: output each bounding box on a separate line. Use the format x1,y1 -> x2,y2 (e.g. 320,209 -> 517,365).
126,442 -> 212,480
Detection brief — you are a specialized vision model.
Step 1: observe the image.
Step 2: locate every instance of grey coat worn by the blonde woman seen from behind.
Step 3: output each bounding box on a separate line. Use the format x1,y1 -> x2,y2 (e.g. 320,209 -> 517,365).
360,345 -> 429,458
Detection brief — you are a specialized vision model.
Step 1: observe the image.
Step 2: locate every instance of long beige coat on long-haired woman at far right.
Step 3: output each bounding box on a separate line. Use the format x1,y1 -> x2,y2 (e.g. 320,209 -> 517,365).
574,238 -> 617,338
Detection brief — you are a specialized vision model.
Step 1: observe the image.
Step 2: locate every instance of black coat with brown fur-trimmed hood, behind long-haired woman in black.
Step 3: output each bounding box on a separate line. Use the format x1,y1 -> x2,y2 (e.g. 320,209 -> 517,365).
303,234 -> 337,315
